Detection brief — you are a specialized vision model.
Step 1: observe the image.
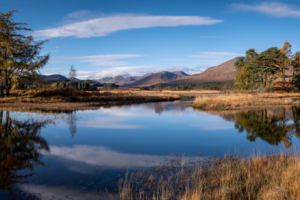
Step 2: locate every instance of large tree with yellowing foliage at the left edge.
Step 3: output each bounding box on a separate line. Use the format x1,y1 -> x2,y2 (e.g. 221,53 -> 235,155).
0,10 -> 50,95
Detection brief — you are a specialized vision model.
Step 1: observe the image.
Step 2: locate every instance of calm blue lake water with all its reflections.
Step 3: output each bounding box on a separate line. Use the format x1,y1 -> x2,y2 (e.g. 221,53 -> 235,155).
0,101 -> 300,199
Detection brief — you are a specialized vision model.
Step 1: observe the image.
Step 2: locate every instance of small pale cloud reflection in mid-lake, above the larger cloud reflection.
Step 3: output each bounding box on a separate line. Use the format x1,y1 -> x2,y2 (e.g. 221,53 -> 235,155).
77,117 -> 142,129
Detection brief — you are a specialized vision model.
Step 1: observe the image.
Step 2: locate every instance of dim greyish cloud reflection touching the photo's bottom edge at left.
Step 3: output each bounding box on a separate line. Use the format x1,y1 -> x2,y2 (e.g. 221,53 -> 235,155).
19,184 -> 110,200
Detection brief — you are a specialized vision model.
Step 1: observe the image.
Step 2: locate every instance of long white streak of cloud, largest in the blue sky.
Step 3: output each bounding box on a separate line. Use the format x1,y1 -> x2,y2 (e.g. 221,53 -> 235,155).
33,11 -> 223,39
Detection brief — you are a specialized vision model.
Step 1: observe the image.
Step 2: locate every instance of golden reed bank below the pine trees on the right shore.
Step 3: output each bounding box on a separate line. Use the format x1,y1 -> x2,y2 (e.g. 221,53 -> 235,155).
193,93 -> 300,110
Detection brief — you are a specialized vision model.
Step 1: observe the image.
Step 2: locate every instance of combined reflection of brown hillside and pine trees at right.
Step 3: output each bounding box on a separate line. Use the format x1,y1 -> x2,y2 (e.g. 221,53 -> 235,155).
204,107 -> 300,148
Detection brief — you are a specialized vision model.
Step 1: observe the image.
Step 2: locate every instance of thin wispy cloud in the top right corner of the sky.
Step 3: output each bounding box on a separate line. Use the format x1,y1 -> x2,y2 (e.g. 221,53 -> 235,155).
230,2 -> 300,17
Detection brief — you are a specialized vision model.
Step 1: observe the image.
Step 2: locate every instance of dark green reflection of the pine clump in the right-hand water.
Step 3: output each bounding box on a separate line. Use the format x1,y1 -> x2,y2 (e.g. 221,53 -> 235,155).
235,108 -> 294,148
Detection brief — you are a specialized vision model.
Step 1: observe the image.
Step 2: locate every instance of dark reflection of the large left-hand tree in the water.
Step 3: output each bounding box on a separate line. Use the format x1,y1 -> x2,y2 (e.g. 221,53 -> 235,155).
0,111 -> 51,196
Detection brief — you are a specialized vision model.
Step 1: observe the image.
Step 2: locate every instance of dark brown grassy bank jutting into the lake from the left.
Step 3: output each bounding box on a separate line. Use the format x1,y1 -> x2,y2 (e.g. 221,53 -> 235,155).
0,88 -> 180,109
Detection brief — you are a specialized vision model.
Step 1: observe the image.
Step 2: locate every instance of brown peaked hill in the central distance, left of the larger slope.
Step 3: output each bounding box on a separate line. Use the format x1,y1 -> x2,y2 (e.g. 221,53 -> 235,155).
123,71 -> 188,87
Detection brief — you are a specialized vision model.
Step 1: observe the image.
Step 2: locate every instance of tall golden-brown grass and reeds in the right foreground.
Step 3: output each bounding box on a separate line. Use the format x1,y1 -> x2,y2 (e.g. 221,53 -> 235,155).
119,153 -> 300,200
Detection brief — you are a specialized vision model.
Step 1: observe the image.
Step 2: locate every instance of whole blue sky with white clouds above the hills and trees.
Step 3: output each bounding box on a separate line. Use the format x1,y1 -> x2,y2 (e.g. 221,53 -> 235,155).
0,0 -> 300,80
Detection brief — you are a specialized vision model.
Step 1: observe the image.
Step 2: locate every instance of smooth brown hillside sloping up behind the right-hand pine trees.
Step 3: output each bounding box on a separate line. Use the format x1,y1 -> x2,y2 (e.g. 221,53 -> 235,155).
167,58 -> 237,85
